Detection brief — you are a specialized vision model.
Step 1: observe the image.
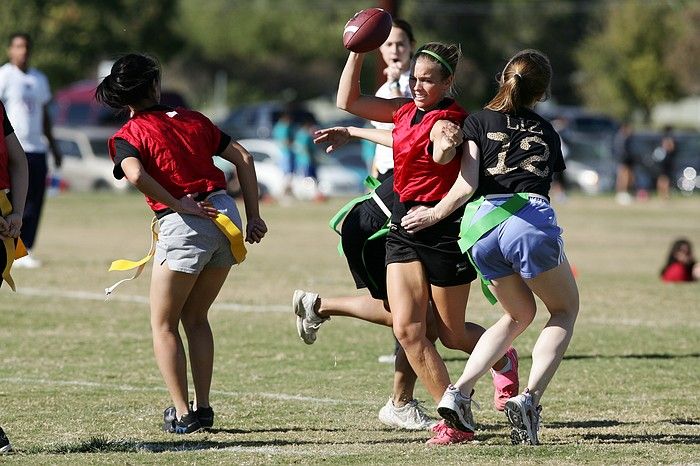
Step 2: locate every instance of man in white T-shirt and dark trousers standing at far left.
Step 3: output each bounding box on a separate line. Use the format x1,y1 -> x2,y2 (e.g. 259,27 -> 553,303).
0,32 -> 62,268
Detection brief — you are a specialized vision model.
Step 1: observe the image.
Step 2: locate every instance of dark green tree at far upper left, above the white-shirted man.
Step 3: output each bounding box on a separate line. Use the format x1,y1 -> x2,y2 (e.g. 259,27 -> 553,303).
0,0 -> 183,88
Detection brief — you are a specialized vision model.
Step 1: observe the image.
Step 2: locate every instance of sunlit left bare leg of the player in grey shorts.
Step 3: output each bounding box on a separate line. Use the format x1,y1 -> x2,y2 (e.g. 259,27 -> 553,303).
150,264 -> 197,417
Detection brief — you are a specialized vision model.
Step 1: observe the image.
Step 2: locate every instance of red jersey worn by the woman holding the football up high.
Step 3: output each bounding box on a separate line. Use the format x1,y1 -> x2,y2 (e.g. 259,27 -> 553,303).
392,101 -> 467,202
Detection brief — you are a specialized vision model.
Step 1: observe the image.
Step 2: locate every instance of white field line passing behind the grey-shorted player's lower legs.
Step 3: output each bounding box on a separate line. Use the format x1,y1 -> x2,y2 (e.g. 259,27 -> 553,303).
0,377 -> 358,404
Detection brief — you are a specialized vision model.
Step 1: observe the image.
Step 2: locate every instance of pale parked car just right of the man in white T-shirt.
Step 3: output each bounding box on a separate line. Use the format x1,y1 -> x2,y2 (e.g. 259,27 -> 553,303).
49,126 -> 130,191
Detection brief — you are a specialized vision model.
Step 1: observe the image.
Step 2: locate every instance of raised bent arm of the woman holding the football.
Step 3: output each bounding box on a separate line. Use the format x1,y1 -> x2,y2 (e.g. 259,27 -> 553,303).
336,52 -> 410,123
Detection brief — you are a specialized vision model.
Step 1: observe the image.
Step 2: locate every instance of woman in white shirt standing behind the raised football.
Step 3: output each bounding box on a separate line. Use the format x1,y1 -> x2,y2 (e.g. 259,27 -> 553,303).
372,19 -> 416,181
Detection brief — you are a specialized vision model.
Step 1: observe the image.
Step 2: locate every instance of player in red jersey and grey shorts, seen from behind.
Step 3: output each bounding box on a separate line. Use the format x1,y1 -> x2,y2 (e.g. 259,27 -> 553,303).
95,54 -> 267,434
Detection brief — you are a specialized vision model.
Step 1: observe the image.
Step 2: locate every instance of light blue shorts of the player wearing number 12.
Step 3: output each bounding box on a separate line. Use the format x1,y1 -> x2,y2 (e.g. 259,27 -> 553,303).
471,196 -> 566,280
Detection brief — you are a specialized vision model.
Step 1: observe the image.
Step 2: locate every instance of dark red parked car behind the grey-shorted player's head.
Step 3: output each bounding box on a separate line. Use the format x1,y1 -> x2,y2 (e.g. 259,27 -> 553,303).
51,80 -> 187,126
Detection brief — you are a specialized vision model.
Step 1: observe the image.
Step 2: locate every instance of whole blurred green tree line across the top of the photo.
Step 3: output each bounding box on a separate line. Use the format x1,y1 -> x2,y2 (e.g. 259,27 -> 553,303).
0,0 -> 700,122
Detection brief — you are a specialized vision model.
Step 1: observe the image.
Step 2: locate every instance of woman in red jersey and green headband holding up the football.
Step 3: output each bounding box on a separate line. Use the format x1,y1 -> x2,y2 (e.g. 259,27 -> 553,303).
329,43 -> 518,443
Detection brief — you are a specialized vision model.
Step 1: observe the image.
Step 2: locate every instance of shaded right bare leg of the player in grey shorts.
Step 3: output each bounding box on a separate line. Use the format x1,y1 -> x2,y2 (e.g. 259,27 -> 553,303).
182,267 -> 230,409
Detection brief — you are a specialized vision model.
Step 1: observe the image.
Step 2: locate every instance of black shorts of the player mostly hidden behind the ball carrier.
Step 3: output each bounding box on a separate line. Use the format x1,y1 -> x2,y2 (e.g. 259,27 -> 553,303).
340,201 -> 387,300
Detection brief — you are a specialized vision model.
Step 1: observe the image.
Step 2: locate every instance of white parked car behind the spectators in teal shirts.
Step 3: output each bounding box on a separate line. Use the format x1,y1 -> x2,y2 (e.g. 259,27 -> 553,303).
215,139 -> 364,199
